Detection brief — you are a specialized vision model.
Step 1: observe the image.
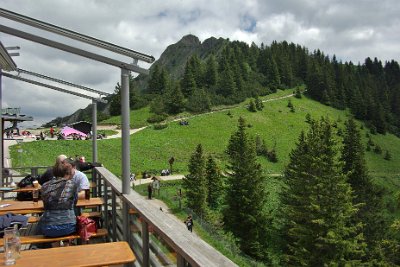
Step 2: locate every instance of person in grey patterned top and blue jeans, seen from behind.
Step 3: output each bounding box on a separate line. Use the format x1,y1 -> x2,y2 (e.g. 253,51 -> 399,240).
37,161 -> 78,237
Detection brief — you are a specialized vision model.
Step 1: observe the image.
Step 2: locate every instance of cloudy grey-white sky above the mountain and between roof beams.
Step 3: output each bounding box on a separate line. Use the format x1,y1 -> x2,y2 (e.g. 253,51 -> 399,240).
0,0 -> 400,127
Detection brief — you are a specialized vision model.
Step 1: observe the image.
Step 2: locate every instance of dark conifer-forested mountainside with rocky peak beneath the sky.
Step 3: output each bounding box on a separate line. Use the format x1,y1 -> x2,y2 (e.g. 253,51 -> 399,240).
103,35 -> 400,138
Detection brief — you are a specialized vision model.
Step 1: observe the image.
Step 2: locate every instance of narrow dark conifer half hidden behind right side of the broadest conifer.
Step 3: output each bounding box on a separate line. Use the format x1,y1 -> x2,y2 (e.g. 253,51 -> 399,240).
341,119 -> 386,251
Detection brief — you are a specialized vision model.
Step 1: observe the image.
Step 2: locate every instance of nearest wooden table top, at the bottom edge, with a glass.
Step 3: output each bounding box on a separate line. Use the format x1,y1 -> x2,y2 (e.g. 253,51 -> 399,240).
0,241 -> 136,267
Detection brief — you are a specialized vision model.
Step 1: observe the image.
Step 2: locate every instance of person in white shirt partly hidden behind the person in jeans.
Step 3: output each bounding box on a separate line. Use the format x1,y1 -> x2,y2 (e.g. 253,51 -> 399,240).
38,155 -> 90,199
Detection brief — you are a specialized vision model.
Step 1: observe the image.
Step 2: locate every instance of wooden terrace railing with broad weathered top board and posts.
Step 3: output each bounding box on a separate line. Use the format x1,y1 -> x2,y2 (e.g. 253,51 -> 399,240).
3,167 -> 236,267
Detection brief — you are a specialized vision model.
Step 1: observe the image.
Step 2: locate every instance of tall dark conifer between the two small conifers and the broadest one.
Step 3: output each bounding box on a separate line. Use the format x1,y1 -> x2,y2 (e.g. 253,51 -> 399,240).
223,118 -> 269,259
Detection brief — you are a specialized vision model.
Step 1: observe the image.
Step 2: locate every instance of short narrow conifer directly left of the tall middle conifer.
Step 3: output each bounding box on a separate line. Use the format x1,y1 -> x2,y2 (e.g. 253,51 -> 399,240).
206,156 -> 223,209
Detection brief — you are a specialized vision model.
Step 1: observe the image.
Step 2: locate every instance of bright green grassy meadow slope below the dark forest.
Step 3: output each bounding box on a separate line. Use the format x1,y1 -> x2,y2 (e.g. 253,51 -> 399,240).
11,91 -> 400,189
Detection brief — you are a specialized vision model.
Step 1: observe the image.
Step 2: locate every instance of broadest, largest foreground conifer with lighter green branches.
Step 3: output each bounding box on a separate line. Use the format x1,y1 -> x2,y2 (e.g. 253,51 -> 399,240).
282,119 -> 364,266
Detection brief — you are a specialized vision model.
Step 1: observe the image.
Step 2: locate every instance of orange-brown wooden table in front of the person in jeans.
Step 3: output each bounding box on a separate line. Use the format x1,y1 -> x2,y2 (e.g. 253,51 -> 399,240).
0,197 -> 104,215
